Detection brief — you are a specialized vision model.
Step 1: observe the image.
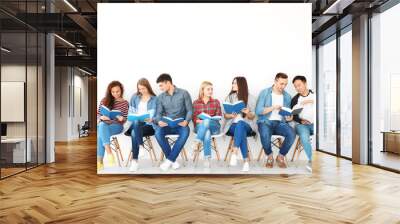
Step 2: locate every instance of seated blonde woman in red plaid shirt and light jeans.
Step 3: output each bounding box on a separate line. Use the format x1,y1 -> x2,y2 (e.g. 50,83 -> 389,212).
193,81 -> 222,168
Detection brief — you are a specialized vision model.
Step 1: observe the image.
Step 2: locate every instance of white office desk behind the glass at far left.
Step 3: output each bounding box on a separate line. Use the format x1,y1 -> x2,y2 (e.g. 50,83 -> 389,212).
1,138 -> 32,163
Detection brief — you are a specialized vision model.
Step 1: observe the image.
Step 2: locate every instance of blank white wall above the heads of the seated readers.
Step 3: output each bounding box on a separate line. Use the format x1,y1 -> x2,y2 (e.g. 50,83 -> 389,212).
98,4 -> 314,102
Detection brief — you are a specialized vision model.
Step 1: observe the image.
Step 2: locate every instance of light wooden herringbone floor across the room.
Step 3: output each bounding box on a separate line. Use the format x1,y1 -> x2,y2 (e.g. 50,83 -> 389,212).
0,134 -> 400,224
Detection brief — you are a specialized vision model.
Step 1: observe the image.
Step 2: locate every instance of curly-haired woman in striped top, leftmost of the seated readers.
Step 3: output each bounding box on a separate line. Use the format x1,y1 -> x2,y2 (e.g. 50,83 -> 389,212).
97,81 -> 128,170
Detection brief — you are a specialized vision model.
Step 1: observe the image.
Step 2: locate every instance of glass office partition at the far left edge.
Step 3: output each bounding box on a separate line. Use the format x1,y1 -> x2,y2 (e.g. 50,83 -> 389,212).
0,1 -> 46,178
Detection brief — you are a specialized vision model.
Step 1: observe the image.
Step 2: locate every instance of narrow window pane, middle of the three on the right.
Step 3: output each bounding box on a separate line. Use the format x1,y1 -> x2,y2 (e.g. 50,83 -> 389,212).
339,26 -> 352,158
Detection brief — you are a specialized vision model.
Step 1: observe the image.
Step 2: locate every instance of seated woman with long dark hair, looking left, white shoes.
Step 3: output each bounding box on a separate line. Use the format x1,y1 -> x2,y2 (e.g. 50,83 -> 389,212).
223,76 -> 256,172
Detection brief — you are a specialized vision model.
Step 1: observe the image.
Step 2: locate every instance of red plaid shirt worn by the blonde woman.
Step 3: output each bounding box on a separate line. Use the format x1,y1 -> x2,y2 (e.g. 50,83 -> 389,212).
193,98 -> 222,128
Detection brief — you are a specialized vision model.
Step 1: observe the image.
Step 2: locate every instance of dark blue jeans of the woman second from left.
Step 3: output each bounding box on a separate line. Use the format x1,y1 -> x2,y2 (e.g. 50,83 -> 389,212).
131,121 -> 154,160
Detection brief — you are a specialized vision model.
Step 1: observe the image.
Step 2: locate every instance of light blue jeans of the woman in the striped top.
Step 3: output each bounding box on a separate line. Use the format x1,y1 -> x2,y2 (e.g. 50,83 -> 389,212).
97,121 -> 123,158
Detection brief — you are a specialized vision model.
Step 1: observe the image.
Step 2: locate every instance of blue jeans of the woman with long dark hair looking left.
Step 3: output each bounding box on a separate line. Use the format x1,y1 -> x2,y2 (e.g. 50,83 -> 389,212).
228,120 -> 252,159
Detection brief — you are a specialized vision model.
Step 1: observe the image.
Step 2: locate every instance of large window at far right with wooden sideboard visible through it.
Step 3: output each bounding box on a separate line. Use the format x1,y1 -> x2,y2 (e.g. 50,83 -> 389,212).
370,4 -> 400,170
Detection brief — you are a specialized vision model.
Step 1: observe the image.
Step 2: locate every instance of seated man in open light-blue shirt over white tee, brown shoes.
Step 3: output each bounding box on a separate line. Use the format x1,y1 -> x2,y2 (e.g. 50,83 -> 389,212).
256,73 -> 296,168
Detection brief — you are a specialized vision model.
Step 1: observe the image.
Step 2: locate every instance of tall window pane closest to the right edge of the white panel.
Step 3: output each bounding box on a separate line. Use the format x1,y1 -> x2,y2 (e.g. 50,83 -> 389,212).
318,36 -> 337,153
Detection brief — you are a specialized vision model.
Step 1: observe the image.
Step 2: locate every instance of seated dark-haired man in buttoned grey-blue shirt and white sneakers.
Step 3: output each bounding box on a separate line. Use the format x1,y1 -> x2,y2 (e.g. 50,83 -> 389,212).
154,74 -> 193,171
